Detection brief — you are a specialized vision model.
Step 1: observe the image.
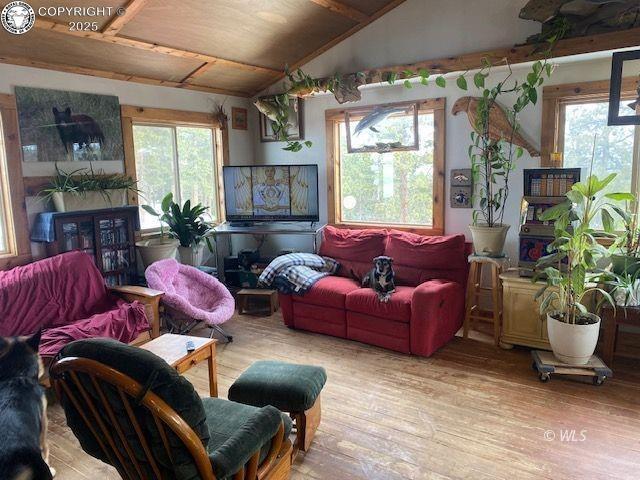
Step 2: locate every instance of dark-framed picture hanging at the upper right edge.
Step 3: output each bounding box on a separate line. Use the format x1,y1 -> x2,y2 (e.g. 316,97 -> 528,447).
607,50 -> 640,125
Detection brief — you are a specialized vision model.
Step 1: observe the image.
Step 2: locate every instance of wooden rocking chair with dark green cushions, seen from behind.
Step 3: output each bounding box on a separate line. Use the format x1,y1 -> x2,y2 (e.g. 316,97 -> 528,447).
51,339 -> 292,480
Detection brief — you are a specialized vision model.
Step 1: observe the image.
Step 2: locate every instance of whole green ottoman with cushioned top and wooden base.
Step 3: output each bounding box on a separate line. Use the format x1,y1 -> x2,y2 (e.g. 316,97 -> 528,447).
228,361 -> 327,452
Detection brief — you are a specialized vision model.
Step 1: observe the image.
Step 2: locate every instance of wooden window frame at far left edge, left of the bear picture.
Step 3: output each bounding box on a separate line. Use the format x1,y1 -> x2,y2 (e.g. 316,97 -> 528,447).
0,94 -> 32,270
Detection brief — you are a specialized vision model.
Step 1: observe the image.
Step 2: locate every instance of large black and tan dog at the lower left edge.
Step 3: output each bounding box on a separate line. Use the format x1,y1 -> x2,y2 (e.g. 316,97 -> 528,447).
0,333 -> 53,480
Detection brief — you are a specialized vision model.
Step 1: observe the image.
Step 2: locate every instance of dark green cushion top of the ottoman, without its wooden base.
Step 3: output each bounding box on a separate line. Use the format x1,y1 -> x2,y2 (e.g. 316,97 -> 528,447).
228,360 -> 327,412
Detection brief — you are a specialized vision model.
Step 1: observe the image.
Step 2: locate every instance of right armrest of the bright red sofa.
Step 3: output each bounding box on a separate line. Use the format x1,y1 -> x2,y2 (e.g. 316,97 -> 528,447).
410,279 -> 464,356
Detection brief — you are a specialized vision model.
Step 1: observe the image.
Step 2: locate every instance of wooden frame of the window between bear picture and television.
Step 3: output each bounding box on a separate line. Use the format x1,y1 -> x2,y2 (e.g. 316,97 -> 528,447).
120,105 -> 229,235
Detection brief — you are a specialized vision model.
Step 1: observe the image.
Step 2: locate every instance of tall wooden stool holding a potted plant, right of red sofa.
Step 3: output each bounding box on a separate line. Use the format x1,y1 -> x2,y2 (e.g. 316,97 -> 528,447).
462,255 -> 508,345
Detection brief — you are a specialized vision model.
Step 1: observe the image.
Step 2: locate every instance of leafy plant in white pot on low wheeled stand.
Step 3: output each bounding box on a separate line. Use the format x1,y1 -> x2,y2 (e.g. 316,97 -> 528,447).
536,173 -> 622,365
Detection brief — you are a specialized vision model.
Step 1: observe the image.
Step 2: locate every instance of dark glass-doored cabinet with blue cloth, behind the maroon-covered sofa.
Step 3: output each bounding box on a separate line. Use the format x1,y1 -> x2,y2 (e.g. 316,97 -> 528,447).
31,207 -> 139,286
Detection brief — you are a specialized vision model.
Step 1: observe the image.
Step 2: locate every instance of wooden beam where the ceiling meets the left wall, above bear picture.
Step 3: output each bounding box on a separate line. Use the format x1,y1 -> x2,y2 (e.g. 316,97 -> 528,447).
0,55 -> 250,97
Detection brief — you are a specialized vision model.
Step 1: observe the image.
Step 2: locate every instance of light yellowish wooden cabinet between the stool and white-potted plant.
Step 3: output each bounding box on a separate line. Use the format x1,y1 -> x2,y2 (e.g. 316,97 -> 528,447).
500,271 -> 551,350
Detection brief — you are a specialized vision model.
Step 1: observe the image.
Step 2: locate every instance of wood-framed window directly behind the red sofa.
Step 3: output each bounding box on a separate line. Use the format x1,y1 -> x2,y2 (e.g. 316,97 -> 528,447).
327,99 -> 444,234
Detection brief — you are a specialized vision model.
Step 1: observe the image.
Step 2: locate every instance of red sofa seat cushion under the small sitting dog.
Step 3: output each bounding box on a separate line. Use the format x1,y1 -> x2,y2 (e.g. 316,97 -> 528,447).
346,286 -> 415,323
